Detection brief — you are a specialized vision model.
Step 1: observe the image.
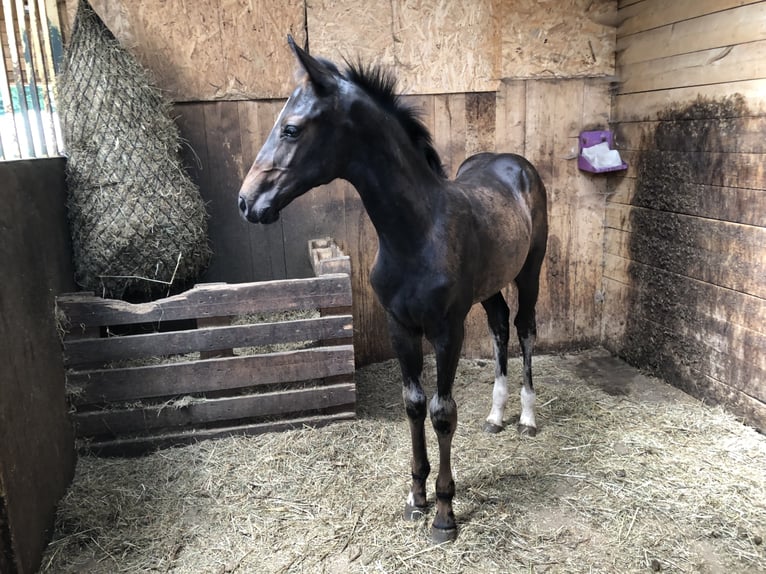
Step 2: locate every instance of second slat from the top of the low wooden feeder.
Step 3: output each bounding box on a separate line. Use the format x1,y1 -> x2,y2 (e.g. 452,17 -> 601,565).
64,315 -> 353,367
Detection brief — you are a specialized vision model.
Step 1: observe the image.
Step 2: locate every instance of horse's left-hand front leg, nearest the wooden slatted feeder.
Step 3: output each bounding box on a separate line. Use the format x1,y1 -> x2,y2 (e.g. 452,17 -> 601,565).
388,316 -> 431,520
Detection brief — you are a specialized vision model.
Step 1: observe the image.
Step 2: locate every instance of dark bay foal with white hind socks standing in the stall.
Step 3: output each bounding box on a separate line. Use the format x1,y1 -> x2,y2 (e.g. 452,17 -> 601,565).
239,37 -> 548,542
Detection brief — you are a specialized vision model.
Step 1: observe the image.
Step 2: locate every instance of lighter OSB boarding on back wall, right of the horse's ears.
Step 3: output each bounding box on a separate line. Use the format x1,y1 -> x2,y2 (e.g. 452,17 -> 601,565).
307,0 -> 616,94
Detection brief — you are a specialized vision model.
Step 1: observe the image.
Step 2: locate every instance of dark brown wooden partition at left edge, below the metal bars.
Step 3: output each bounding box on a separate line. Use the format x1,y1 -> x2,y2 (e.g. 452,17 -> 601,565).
0,158 -> 75,574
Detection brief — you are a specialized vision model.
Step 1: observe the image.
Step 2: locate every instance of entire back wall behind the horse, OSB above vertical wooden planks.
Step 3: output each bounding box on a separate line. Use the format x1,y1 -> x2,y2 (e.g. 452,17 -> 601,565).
60,0 -> 616,364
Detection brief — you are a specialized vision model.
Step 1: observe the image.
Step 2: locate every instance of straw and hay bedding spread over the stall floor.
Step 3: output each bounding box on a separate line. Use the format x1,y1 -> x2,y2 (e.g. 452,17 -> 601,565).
42,351 -> 766,574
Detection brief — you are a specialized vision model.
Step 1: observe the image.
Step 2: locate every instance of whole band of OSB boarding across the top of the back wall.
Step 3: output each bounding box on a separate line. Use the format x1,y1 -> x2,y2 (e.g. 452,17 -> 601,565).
66,0 -> 616,101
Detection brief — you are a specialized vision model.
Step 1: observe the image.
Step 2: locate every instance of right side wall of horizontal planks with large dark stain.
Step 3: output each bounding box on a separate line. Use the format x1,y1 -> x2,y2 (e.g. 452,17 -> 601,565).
603,0 -> 766,429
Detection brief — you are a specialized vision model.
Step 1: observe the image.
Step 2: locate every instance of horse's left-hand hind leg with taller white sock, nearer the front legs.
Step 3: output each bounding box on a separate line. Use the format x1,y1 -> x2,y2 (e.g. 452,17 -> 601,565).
481,292 -> 511,433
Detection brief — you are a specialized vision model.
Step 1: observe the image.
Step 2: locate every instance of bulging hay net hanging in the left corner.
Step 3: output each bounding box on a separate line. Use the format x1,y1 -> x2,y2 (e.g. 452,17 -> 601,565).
59,0 -> 210,300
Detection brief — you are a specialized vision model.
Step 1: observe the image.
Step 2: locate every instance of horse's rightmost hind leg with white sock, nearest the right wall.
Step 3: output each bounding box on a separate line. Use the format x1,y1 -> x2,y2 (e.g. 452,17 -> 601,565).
513,250 -> 544,436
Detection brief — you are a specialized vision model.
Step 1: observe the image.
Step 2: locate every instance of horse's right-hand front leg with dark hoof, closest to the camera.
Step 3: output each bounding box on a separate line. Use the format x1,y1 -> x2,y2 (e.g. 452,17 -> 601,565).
429,318 -> 464,544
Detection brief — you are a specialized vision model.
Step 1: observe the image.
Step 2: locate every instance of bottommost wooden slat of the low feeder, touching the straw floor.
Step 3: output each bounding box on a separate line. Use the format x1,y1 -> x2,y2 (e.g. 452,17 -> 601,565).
78,411 -> 355,456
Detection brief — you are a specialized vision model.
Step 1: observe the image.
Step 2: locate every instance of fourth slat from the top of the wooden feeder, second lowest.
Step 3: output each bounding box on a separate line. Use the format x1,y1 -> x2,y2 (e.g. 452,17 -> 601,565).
74,383 -> 356,437
